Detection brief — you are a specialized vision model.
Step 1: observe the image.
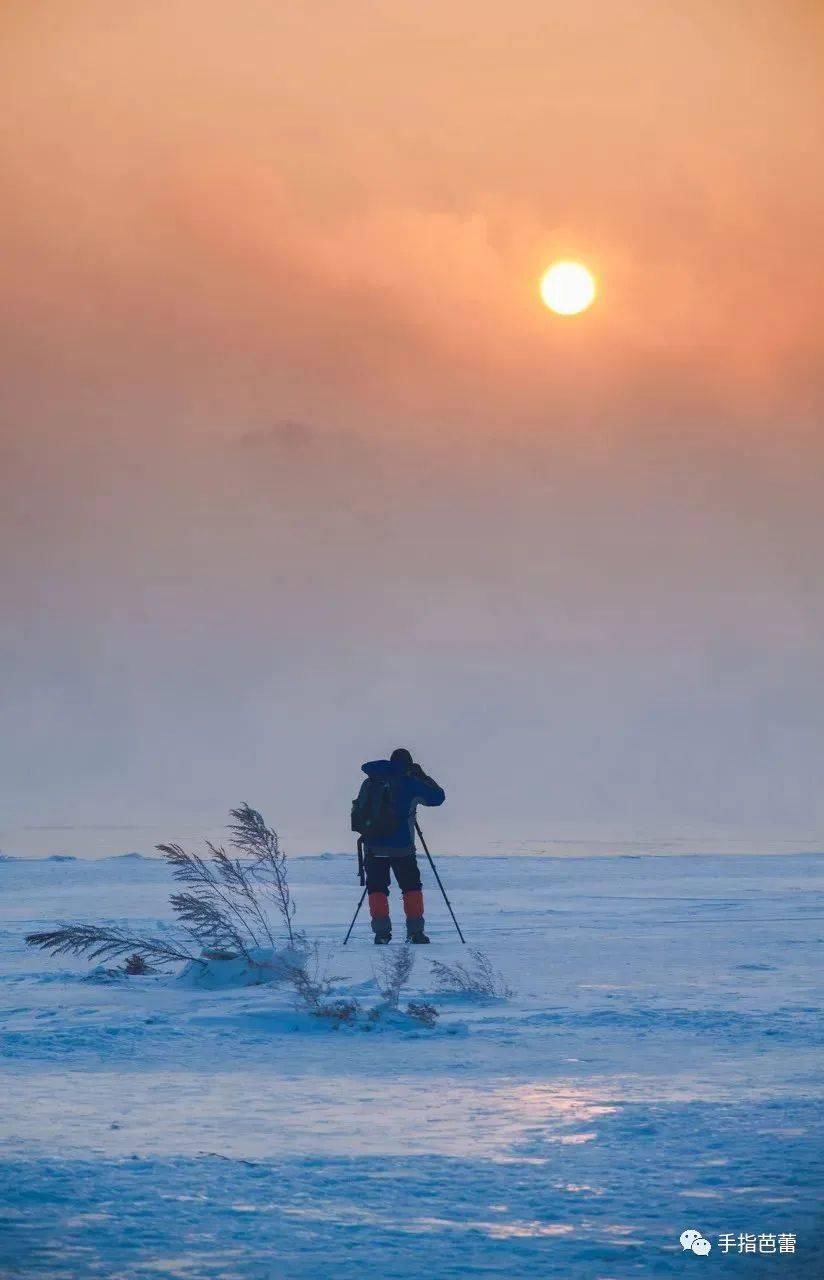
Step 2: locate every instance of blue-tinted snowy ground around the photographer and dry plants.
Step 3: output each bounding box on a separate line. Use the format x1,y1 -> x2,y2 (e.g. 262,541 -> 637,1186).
0,855 -> 824,1280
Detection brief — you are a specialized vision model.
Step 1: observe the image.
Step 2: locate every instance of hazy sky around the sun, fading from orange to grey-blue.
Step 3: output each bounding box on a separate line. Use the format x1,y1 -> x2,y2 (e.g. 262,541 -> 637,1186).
0,0 -> 824,844
